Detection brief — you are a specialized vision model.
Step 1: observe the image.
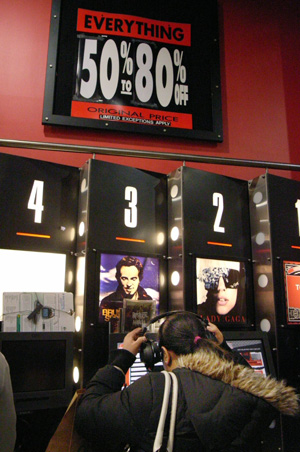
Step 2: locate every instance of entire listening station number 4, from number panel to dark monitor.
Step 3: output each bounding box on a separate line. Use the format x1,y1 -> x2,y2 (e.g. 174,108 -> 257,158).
0,153 -> 79,413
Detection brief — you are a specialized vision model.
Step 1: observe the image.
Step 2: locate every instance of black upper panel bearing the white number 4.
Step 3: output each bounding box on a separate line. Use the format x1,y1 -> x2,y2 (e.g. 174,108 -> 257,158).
0,154 -> 79,251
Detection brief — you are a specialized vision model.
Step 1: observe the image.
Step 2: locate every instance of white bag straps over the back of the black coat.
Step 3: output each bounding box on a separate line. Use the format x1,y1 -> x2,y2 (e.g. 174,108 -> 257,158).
153,370 -> 178,452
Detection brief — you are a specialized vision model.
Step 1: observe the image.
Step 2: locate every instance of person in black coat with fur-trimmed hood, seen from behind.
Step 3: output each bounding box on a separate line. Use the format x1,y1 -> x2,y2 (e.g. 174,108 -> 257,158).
76,312 -> 299,452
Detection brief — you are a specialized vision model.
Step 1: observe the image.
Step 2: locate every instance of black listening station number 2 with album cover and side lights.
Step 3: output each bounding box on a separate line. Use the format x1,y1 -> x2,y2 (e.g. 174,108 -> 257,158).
168,167 -> 254,329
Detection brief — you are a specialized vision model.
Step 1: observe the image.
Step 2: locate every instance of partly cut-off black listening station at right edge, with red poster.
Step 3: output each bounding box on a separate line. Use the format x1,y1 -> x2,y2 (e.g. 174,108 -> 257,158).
249,174 -> 300,451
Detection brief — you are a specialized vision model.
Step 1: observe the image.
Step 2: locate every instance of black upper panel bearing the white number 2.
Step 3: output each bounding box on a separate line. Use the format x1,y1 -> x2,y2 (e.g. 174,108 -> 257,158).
169,167 -> 251,258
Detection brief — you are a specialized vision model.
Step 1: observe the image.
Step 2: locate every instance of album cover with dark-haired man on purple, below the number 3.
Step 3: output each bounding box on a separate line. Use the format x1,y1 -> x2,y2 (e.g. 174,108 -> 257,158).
99,253 -> 160,323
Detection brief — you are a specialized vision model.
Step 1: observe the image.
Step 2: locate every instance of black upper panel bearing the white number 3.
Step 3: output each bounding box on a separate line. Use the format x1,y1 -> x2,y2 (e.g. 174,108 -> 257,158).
79,160 -> 167,254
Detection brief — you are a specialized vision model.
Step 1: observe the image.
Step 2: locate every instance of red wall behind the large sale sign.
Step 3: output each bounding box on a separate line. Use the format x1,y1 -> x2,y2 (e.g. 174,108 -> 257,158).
0,0 -> 300,180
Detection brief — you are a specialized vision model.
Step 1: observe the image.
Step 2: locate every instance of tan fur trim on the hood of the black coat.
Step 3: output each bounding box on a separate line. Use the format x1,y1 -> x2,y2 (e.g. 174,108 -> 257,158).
178,350 -> 299,416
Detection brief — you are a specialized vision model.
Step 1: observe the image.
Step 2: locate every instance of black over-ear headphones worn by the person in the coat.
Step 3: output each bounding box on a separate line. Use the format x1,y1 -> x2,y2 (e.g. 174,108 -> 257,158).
140,311 -> 216,371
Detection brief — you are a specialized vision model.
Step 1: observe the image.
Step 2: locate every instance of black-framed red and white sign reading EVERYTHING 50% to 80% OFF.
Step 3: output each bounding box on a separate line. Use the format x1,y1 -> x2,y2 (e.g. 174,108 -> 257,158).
43,0 -> 222,141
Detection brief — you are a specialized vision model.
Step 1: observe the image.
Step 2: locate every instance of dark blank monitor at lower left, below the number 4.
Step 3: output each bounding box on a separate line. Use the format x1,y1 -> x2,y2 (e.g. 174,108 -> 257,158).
0,331 -> 74,412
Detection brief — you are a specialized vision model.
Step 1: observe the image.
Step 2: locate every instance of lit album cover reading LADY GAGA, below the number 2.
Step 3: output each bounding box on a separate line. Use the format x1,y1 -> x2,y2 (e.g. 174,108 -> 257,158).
196,258 -> 247,326
